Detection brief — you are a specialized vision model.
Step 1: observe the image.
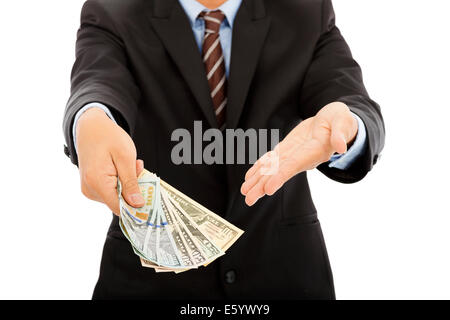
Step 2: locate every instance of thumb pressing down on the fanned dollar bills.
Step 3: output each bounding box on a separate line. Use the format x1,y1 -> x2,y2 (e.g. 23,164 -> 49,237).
113,155 -> 145,208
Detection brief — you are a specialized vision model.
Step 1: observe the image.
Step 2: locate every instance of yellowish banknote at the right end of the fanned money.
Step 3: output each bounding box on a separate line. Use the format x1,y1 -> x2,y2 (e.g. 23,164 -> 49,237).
161,180 -> 244,251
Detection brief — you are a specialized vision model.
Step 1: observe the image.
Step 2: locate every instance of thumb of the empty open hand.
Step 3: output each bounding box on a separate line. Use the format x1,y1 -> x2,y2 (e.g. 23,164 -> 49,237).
330,114 -> 358,154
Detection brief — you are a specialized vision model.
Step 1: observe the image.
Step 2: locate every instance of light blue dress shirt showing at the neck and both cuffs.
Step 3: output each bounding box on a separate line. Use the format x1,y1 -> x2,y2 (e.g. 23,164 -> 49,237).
73,0 -> 366,170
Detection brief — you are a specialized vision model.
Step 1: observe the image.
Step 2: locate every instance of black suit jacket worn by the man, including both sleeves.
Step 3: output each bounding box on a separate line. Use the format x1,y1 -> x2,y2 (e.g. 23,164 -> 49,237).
64,0 -> 384,299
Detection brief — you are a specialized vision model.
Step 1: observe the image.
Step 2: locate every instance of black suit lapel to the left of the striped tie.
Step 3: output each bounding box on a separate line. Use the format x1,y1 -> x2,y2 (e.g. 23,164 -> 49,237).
150,0 -> 217,127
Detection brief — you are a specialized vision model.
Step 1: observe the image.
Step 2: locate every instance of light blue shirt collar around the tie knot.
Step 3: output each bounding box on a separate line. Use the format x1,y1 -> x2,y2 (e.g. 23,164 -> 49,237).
178,0 -> 242,27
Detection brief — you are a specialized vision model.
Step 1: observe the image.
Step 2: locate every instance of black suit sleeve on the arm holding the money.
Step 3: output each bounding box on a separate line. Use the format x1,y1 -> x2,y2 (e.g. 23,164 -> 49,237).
63,1 -> 140,168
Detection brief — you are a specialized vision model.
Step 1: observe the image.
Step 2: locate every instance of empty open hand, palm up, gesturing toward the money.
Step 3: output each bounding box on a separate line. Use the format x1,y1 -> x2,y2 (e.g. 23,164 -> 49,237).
241,102 -> 358,206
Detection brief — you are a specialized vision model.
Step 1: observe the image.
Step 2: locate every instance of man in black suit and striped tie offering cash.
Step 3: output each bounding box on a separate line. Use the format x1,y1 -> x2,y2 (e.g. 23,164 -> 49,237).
63,0 -> 385,299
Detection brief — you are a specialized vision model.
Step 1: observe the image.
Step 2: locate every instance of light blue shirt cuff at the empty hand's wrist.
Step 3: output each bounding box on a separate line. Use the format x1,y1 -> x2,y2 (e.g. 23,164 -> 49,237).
328,113 -> 367,170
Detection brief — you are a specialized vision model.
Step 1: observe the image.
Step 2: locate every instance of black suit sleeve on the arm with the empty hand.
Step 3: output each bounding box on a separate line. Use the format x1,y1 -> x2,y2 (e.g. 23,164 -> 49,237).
301,0 -> 385,183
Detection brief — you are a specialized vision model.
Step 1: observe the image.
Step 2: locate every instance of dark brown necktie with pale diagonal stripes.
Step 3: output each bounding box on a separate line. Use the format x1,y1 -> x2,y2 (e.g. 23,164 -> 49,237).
199,10 -> 227,130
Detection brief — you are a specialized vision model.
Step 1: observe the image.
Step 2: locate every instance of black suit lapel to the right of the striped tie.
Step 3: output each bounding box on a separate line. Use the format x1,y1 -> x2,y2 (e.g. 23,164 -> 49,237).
227,0 -> 270,128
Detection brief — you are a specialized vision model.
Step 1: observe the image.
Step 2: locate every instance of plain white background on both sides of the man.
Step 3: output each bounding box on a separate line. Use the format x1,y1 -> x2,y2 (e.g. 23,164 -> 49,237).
0,0 -> 450,299
